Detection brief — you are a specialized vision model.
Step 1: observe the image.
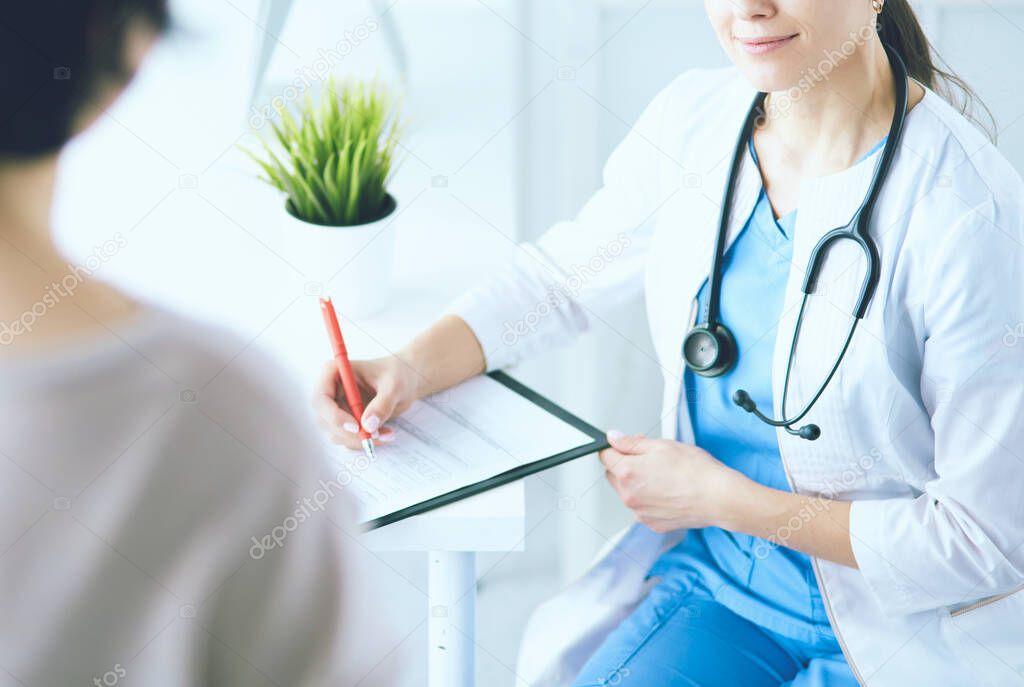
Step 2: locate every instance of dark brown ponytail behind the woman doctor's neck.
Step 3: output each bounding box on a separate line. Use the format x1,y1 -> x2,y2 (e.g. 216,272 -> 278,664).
879,0 -> 995,142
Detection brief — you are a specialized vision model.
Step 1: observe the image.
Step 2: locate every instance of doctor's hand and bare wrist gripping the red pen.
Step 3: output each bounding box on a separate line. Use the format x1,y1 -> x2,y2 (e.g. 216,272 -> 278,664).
312,315 -> 485,449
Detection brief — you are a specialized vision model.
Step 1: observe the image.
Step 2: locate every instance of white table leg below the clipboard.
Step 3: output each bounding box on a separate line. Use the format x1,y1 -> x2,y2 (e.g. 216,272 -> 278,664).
427,551 -> 476,687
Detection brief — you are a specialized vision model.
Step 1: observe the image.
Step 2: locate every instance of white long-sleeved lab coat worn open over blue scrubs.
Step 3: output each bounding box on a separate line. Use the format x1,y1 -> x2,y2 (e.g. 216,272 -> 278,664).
452,69 -> 1024,687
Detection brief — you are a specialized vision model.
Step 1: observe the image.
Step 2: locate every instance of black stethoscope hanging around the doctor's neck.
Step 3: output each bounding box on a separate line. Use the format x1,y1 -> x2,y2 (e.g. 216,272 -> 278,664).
683,45 -> 908,441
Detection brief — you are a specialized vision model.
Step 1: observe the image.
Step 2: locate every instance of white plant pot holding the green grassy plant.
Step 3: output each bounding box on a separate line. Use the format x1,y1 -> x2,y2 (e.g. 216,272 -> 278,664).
282,195 -> 397,317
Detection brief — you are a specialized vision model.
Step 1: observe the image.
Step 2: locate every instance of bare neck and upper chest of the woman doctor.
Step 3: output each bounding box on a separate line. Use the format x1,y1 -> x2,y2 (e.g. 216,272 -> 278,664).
758,37 -> 924,173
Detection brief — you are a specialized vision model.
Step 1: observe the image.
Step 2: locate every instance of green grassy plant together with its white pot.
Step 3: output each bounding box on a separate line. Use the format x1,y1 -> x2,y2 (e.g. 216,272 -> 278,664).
246,78 -> 401,316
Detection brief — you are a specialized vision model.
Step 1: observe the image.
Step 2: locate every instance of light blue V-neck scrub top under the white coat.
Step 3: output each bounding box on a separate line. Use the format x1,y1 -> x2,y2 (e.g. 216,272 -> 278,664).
649,139 -> 885,653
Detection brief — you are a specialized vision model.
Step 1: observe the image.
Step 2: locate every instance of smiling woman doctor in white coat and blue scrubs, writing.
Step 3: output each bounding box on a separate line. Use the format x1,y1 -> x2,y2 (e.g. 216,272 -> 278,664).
315,0 -> 1024,687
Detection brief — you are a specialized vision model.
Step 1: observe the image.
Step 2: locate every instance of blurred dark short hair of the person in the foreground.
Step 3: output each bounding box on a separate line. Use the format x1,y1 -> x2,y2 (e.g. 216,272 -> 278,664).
0,0 -> 168,158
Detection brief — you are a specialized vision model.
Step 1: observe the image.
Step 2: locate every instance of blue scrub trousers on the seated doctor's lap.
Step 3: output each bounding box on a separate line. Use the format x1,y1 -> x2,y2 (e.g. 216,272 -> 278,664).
573,584 -> 857,687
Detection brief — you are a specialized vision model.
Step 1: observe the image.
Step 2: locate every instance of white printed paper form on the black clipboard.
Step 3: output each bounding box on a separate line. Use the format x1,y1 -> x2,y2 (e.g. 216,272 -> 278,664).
335,376 -> 594,521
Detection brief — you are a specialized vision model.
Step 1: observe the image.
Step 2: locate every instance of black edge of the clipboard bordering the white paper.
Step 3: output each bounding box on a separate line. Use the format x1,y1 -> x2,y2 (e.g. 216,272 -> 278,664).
362,371 -> 609,530
